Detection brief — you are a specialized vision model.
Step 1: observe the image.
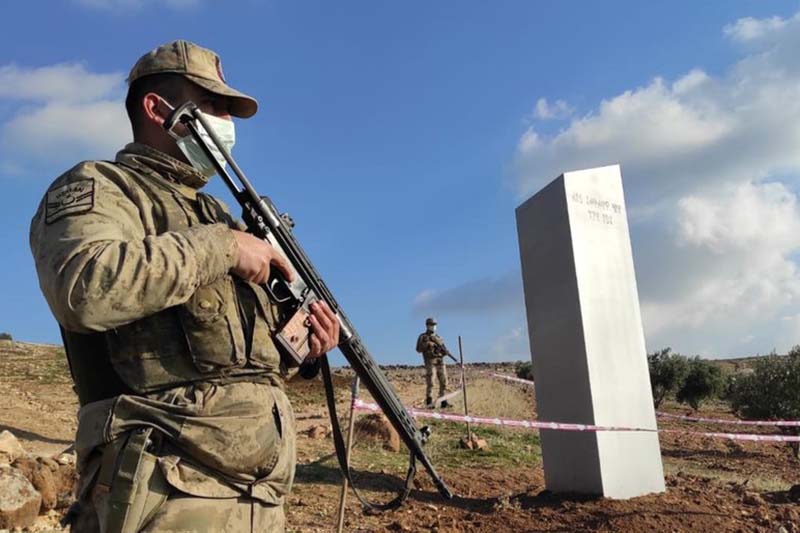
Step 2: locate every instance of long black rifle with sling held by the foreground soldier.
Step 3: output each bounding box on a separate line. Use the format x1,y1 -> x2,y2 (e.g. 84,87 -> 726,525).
164,102 -> 453,510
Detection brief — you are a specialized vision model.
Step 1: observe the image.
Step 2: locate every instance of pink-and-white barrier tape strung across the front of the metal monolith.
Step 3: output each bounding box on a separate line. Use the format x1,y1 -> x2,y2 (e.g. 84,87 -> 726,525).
353,399 -> 800,442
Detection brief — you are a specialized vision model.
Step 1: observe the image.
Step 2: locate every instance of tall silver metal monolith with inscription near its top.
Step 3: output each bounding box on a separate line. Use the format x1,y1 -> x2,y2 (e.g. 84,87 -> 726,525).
516,165 -> 665,499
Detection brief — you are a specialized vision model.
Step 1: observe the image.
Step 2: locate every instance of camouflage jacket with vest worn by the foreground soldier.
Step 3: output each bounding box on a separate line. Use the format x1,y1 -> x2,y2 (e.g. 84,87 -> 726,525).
30,144 -> 294,503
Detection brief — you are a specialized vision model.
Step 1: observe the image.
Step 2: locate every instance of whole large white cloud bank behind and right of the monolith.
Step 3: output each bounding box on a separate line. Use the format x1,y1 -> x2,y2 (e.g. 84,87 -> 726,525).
515,9 -> 800,355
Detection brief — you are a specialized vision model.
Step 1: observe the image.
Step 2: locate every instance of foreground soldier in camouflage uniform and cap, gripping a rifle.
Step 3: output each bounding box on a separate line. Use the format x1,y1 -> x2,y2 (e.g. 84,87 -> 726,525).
30,41 -> 339,532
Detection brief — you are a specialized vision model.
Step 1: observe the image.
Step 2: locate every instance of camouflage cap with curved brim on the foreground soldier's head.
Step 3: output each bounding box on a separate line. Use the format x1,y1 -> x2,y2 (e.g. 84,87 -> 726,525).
128,40 -> 258,118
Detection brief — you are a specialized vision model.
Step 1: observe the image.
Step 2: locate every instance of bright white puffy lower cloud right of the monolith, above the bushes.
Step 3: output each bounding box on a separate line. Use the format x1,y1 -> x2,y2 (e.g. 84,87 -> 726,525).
642,179 -> 800,336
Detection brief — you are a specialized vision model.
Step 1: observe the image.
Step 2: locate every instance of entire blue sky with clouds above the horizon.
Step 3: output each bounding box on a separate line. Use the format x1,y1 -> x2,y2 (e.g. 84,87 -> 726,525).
0,0 -> 800,363
